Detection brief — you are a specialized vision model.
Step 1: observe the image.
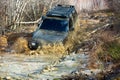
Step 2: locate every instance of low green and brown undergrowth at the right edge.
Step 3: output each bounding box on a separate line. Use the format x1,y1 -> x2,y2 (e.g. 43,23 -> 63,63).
96,41 -> 120,62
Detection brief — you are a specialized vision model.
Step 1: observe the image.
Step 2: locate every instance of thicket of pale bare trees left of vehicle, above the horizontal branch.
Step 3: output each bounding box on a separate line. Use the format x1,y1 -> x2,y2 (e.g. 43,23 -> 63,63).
0,0 -> 44,30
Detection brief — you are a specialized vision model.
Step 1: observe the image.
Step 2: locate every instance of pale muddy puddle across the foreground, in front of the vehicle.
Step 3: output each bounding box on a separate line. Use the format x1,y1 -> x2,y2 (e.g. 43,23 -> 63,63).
0,53 -> 101,80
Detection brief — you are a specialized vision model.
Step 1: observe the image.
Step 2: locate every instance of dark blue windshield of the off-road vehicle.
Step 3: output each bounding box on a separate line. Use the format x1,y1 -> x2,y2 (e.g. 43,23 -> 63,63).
40,19 -> 68,32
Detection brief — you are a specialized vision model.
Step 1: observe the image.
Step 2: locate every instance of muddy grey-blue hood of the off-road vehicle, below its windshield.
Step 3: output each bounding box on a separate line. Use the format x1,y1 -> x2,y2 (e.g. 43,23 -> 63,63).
32,30 -> 68,44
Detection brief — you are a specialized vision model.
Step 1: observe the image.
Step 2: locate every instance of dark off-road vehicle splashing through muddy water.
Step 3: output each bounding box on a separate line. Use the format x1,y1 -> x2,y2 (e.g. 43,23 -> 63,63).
28,5 -> 77,50
